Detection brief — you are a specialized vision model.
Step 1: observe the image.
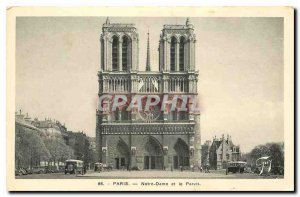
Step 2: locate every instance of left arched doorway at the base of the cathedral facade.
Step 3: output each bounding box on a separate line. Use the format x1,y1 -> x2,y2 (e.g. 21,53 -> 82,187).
114,138 -> 130,169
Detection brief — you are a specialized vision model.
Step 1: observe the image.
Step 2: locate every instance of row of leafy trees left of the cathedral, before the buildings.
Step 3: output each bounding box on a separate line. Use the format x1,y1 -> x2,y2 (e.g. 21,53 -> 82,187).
15,124 -> 93,168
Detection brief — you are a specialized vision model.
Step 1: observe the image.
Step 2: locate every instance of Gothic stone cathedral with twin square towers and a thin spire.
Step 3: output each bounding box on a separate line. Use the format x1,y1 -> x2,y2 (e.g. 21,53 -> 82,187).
96,19 -> 201,170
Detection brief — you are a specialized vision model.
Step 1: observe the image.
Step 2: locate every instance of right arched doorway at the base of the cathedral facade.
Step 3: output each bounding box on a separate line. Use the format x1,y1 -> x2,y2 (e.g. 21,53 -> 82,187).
173,138 -> 190,169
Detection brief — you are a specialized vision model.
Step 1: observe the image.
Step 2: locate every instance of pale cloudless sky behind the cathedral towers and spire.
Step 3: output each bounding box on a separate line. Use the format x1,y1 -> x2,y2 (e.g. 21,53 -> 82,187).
16,17 -> 284,152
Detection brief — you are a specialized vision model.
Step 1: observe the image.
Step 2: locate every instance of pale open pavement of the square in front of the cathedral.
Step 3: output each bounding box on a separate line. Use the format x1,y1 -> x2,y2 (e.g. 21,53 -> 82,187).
16,170 -> 283,179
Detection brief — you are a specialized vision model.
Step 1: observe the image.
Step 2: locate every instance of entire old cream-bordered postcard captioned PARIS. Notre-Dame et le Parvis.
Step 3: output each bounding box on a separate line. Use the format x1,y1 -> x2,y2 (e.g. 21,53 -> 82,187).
7,7 -> 295,191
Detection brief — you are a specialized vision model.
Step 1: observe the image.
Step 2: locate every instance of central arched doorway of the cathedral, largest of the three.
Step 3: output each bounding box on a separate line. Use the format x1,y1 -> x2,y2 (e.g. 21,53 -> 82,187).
144,136 -> 163,170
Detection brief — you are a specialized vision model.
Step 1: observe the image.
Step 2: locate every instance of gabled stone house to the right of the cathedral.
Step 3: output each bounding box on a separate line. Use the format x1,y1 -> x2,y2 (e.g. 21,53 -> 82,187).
202,135 -> 241,169
